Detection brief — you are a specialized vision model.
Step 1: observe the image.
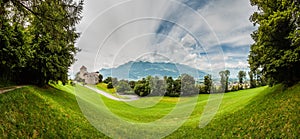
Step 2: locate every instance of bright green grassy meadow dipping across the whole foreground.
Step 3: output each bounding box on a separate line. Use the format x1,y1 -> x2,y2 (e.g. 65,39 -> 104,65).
0,84 -> 300,138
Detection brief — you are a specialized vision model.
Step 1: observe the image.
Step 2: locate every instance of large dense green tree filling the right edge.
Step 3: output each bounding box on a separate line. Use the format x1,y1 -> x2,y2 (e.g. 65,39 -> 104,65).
248,0 -> 300,85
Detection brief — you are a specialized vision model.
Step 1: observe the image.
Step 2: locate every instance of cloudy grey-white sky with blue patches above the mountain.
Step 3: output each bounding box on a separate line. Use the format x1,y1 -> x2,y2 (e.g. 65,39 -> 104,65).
71,0 -> 256,77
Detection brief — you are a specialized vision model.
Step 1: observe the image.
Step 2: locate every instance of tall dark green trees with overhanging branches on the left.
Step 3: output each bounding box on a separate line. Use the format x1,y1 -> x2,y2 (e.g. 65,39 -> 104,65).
0,0 -> 83,86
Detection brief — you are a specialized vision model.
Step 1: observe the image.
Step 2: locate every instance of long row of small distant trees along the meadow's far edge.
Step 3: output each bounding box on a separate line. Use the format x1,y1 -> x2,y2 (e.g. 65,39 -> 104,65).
99,70 -> 262,97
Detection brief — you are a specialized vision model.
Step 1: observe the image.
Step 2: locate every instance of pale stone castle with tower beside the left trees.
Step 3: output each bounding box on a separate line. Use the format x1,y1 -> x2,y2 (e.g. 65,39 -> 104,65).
76,66 -> 99,84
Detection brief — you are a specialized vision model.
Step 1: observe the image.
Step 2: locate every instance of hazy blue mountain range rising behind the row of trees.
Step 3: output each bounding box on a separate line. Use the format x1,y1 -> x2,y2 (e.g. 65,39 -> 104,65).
99,61 -> 206,80
